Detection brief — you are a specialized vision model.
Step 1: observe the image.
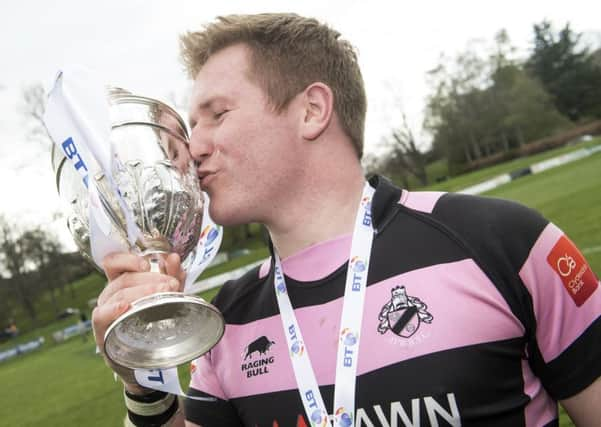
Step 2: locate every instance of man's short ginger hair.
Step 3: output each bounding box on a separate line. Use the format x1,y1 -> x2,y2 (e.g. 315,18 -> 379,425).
180,13 -> 367,158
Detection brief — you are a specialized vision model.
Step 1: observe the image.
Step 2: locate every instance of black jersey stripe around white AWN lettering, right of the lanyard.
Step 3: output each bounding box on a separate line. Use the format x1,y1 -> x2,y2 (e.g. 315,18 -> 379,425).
359,339 -> 529,426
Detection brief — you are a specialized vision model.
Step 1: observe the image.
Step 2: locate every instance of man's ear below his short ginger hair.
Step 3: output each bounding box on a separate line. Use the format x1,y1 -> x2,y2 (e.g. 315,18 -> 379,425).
301,82 -> 334,141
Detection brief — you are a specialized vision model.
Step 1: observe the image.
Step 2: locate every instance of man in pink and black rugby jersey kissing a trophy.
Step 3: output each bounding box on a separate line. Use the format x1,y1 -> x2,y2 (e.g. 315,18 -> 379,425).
94,14 -> 601,427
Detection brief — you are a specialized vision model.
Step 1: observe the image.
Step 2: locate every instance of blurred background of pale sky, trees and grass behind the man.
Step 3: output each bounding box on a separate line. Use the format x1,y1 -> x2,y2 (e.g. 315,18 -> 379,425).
0,0 -> 601,426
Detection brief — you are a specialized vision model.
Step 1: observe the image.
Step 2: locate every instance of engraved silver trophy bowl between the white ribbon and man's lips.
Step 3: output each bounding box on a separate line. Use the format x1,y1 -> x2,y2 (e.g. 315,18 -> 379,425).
104,90 -> 203,259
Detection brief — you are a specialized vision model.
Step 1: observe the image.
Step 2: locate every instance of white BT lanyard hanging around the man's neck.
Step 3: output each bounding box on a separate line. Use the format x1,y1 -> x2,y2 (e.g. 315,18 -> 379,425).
274,183 -> 375,427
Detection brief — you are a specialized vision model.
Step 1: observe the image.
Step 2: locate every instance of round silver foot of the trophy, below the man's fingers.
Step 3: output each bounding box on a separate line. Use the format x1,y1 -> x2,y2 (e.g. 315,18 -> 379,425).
104,292 -> 225,369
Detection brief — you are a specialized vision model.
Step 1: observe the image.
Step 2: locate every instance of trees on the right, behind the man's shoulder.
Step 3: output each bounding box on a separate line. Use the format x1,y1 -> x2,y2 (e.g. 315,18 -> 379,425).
366,21 -> 601,187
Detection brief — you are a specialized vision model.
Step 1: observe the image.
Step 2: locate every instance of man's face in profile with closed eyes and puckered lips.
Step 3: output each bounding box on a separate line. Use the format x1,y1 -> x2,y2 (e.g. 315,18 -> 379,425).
190,45 -> 300,225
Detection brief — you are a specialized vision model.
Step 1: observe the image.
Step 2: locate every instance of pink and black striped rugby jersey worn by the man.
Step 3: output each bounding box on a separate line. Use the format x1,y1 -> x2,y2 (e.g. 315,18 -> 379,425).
185,177 -> 601,427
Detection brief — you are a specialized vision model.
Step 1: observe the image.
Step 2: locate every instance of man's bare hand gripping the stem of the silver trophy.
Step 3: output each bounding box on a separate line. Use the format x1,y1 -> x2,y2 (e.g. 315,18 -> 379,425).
92,253 -> 185,394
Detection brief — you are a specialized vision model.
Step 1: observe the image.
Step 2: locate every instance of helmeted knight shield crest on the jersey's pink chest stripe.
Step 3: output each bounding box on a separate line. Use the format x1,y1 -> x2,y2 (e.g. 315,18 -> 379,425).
378,286 -> 434,338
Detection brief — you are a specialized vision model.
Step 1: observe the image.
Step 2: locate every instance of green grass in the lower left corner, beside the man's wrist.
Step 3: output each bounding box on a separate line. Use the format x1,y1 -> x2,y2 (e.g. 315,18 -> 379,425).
0,338 -> 124,427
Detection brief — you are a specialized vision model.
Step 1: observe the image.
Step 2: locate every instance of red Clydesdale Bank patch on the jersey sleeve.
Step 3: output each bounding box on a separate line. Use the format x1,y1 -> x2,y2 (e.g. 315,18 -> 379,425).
547,236 -> 599,307
